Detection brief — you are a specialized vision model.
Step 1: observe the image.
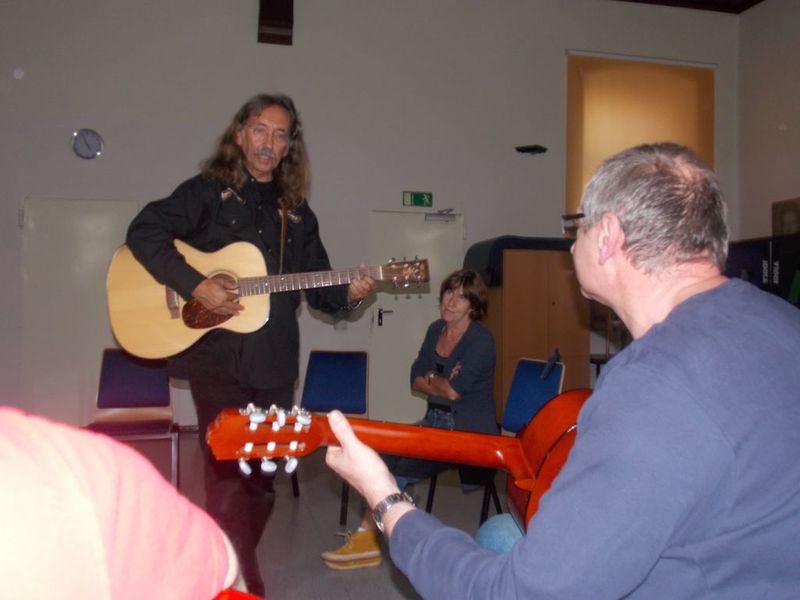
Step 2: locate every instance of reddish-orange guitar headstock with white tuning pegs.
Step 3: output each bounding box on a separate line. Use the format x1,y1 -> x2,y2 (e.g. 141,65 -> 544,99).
206,404 -> 335,475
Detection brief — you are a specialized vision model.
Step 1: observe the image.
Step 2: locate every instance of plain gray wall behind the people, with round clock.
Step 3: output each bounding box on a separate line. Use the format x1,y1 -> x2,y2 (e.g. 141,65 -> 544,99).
0,0 -> 800,414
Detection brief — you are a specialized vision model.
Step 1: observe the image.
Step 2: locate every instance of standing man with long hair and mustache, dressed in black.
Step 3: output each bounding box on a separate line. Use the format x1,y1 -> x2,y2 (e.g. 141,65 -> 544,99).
127,94 -> 375,595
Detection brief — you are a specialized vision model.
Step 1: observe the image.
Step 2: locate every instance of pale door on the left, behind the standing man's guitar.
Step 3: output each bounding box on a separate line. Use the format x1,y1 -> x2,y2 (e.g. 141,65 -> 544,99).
21,199 -> 138,425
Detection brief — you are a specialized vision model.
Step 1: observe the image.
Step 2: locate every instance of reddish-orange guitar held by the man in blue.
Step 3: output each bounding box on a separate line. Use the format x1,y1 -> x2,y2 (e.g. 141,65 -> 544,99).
206,389 -> 591,527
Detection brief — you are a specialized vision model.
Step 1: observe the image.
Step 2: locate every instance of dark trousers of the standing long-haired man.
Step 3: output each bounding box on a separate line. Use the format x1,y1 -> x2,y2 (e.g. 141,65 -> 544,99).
189,364 -> 294,597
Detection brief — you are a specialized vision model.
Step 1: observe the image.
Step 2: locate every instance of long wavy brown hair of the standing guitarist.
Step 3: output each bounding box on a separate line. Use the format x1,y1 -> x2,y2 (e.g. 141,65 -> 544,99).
202,94 -> 311,208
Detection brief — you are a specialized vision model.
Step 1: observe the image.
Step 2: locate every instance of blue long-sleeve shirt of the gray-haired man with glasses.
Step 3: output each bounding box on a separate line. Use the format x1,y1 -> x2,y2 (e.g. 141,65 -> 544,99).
390,280 -> 800,600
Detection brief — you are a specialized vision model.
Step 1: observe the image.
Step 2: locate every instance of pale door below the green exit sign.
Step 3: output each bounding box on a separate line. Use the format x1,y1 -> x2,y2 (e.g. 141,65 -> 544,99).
369,210 -> 464,423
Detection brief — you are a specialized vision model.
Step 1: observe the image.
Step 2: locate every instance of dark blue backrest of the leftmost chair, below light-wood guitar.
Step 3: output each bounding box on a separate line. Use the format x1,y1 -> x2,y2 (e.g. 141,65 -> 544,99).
97,348 -> 170,408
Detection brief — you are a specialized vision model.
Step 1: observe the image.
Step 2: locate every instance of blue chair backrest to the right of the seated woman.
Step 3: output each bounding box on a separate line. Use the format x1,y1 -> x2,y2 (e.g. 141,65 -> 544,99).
503,358 -> 564,433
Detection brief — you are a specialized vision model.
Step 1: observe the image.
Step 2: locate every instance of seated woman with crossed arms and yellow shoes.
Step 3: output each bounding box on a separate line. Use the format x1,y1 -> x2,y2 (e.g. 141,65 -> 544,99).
322,270 -> 498,569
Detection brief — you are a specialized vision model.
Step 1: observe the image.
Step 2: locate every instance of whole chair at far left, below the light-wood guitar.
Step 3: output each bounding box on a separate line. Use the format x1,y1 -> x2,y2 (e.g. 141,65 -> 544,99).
86,348 -> 180,487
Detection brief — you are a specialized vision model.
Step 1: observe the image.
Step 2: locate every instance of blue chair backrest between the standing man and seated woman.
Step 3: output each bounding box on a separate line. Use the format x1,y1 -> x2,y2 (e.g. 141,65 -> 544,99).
300,350 -> 367,415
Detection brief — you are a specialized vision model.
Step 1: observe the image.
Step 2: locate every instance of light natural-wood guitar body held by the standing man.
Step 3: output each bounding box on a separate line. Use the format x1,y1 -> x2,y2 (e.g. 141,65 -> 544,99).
106,240 -> 269,358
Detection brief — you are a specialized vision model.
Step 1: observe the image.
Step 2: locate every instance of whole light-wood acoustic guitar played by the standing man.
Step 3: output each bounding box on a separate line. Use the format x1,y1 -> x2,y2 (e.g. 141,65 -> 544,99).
106,240 -> 429,358
